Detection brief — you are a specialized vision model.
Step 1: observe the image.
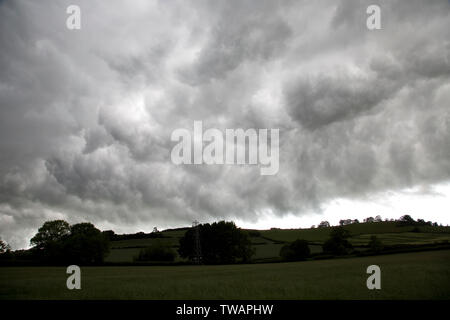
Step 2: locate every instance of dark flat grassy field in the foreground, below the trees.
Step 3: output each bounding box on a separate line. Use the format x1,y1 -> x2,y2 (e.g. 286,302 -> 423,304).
0,250 -> 450,299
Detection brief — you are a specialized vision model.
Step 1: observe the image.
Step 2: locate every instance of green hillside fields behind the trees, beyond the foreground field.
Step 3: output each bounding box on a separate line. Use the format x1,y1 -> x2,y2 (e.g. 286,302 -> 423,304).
106,222 -> 450,262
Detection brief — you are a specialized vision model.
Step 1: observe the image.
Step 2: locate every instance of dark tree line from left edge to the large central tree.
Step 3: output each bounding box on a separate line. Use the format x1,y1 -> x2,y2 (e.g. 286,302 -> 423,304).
0,220 -> 253,265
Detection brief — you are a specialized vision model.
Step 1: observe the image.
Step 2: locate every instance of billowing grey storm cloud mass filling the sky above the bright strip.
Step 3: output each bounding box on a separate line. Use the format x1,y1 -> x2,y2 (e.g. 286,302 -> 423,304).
0,0 -> 450,248
